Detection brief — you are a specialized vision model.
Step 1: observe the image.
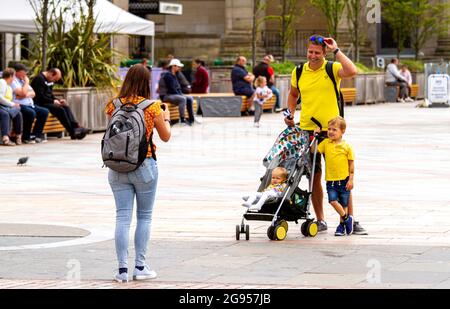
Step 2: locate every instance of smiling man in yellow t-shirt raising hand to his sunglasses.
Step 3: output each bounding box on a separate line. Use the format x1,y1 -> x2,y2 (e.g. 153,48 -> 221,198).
284,35 -> 366,234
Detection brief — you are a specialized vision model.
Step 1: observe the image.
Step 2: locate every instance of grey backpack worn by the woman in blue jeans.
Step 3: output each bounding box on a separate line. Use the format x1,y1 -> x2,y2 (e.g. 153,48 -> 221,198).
102,99 -> 156,173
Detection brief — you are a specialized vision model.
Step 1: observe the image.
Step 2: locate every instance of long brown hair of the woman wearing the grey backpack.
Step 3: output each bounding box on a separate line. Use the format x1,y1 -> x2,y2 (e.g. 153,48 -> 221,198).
119,63 -> 151,99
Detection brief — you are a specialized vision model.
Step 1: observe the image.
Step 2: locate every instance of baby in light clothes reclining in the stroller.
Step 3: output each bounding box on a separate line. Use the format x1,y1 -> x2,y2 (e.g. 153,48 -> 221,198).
242,167 -> 288,212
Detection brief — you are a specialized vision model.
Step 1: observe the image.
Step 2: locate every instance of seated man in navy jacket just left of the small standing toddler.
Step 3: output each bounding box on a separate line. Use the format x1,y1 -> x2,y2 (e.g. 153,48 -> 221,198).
231,56 -> 255,102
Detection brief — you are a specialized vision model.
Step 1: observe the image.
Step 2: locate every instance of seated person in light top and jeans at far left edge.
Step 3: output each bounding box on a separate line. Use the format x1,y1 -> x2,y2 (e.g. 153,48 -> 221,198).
0,68 -> 23,146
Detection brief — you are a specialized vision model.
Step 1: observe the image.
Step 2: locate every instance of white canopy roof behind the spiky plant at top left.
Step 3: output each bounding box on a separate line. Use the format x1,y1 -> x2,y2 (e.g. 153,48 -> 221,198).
0,0 -> 155,36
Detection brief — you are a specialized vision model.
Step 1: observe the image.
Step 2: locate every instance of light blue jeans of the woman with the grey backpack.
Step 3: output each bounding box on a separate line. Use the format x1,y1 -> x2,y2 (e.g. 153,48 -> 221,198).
108,158 -> 158,268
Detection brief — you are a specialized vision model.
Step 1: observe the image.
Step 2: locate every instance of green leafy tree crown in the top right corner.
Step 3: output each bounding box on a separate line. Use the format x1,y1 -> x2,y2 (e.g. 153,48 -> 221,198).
410,0 -> 450,60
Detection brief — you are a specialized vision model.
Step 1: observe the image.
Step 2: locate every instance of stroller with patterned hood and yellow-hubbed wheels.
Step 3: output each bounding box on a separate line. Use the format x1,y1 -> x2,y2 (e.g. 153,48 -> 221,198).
236,119 -> 322,240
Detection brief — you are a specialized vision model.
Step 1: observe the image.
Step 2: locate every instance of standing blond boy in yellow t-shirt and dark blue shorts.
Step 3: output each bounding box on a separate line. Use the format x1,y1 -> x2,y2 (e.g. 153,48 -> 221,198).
317,116 -> 355,236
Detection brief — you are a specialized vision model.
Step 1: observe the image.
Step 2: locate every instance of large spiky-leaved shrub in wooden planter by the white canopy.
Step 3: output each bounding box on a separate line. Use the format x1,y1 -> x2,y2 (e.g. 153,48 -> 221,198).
29,0 -> 120,131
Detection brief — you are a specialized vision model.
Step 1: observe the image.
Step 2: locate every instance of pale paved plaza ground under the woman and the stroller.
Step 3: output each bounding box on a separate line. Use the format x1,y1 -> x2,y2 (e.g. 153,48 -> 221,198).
0,103 -> 450,288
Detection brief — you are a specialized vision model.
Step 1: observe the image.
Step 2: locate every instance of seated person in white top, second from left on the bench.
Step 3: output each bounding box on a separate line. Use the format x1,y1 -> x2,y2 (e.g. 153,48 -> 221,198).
11,63 -> 48,144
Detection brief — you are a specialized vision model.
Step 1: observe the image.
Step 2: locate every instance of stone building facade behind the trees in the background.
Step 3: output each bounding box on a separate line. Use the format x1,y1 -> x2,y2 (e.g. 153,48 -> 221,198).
0,0 -> 450,68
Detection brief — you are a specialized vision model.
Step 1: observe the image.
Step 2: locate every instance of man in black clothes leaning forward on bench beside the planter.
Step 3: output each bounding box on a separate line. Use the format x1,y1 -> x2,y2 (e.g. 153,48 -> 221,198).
31,68 -> 89,139
